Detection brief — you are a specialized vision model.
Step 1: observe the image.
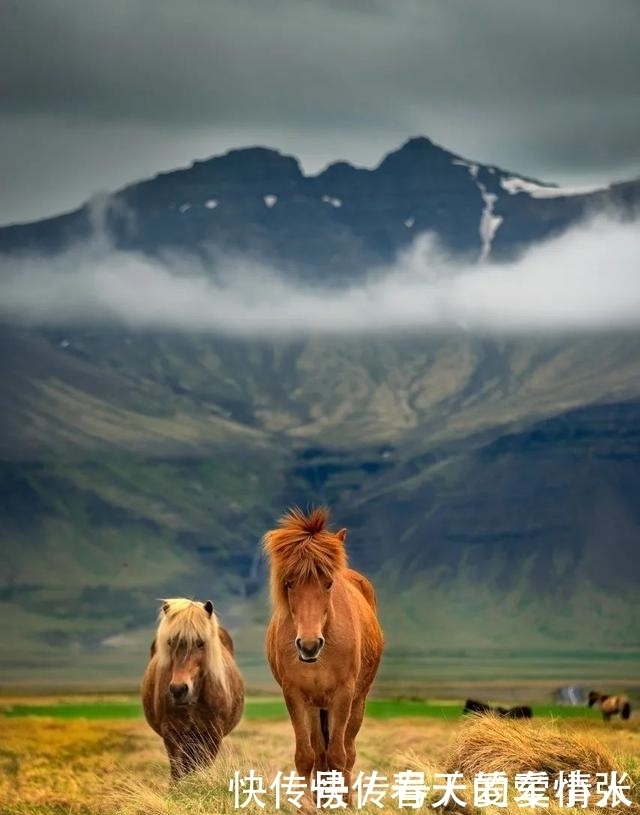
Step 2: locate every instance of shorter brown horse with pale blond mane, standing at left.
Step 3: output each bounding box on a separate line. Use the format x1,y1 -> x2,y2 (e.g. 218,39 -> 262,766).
141,597 -> 244,781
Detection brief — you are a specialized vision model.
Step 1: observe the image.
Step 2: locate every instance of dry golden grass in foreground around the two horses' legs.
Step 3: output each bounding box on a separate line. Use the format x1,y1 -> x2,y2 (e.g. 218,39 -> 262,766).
0,717 -> 640,815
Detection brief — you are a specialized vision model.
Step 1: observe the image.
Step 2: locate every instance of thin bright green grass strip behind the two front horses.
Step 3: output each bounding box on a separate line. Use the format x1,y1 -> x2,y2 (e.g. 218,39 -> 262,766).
0,698 -> 600,721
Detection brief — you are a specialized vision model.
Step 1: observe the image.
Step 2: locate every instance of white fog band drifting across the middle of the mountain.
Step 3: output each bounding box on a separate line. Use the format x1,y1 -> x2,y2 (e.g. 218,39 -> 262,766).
0,217 -> 640,338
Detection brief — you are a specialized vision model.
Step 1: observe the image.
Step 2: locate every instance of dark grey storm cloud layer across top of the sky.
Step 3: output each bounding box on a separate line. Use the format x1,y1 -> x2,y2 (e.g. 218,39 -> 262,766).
6,0 -> 640,124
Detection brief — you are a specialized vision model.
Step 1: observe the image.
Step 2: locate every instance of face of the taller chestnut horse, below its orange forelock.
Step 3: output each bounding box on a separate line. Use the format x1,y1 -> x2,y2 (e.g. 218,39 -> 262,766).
287,579 -> 332,662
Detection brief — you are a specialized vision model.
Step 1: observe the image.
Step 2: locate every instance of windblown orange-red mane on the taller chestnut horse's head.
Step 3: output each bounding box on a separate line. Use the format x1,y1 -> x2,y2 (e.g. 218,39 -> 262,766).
262,507 -> 348,608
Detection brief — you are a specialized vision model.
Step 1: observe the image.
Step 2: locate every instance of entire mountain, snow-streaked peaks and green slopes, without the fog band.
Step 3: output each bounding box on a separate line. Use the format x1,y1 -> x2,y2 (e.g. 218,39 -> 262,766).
0,138 -> 640,681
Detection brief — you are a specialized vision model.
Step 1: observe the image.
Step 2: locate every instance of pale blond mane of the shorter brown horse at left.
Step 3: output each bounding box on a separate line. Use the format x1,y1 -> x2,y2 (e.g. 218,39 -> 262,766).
154,597 -> 228,692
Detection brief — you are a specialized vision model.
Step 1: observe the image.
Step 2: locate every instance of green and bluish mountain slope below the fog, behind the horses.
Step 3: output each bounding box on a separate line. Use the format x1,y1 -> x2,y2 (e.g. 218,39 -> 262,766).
0,329 -> 640,680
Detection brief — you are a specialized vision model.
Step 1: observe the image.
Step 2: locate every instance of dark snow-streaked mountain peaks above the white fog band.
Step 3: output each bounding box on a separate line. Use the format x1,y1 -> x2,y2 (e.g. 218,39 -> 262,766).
5,137 -> 640,282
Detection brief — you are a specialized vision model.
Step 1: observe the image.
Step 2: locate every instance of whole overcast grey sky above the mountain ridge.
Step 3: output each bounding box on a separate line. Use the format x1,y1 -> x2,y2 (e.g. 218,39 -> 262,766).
0,0 -> 640,224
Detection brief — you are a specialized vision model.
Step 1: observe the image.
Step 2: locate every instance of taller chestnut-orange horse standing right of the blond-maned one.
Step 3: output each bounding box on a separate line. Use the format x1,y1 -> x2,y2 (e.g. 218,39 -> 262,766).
263,508 -> 384,803
